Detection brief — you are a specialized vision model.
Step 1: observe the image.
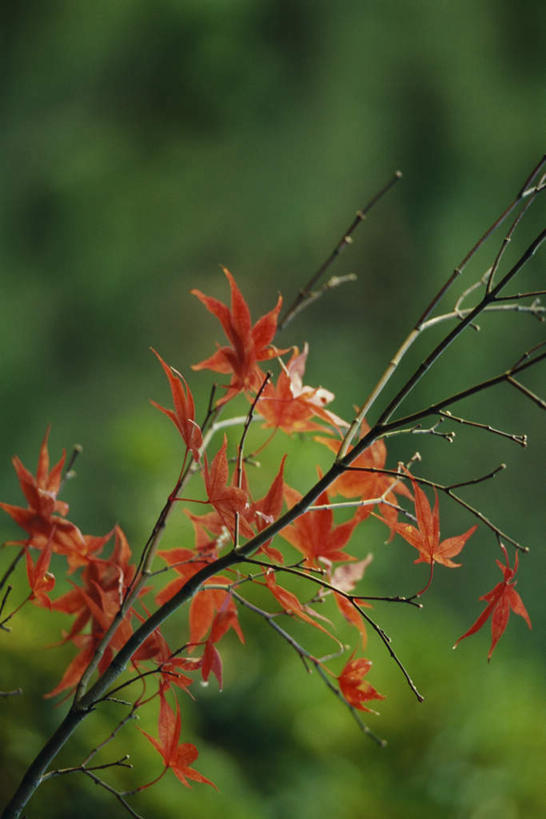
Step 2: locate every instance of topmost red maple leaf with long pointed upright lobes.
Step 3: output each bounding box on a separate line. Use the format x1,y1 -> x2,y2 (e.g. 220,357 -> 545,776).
191,267 -> 286,404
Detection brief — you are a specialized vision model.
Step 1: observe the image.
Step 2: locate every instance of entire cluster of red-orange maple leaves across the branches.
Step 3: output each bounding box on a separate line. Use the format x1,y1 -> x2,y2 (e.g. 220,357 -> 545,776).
0,270 -> 530,800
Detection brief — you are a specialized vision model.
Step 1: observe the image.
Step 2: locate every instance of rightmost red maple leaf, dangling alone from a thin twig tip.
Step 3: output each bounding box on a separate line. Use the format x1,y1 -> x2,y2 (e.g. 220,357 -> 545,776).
453,543 -> 532,661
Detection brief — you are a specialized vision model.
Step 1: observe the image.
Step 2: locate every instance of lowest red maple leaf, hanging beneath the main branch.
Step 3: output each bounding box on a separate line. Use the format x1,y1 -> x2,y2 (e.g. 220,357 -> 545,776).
138,694 -> 216,790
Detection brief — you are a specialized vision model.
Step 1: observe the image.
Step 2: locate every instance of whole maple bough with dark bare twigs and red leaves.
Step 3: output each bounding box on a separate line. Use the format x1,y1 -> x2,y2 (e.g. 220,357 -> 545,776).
0,161 -> 546,817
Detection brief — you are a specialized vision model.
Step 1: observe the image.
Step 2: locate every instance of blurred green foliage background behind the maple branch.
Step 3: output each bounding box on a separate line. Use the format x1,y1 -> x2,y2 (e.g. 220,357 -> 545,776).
0,0 -> 546,819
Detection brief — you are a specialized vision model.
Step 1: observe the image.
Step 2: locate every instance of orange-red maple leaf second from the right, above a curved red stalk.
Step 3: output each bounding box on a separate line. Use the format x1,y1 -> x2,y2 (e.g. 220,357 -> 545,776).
380,480 -> 478,576
